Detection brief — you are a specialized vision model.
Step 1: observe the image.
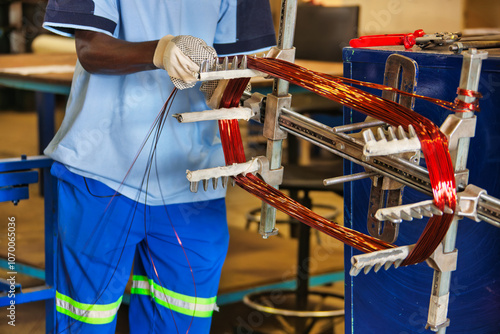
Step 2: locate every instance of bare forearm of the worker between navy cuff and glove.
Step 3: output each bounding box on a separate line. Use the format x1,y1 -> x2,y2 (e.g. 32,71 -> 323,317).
75,30 -> 158,75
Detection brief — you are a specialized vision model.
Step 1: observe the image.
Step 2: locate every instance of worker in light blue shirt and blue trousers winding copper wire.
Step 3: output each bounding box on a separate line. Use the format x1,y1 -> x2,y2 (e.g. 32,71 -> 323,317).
44,0 -> 275,334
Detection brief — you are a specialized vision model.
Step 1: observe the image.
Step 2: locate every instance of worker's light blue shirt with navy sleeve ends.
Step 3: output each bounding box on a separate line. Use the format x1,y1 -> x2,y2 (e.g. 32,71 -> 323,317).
44,0 -> 274,205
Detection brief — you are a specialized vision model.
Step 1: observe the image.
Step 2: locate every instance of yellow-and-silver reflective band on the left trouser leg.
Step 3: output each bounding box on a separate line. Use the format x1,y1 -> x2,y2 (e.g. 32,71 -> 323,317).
56,291 -> 122,325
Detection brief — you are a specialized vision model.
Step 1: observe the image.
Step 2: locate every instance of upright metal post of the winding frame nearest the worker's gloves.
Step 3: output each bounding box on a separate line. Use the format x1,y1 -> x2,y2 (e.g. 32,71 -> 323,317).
259,0 -> 297,238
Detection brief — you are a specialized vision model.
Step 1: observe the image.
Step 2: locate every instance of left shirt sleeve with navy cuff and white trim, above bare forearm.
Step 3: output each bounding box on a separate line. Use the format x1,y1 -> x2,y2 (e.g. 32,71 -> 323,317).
43,0 -> 119,36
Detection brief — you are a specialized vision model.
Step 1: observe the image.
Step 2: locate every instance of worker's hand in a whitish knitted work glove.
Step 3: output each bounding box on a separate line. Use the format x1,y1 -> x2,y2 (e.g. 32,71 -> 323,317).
153,35 -> 217,89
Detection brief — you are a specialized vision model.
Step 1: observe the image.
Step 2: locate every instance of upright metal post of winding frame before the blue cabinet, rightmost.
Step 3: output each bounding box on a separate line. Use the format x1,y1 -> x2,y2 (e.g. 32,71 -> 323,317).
427,49 -> 488,334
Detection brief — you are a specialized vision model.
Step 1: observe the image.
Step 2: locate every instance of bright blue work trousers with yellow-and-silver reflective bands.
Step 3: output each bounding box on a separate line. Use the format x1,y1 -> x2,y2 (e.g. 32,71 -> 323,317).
52,163 -> 229,334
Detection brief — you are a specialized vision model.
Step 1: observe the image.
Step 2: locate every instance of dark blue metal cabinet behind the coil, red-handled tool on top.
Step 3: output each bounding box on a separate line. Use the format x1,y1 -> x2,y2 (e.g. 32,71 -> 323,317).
343,48 -> 500,334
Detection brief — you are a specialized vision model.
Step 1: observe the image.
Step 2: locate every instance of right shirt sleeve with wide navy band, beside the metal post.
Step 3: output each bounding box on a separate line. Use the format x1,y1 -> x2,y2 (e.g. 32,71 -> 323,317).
214,0 -> 276,55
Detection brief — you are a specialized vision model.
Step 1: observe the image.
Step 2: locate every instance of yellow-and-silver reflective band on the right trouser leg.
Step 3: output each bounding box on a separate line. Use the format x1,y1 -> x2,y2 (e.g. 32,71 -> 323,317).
131,275 -> 218,318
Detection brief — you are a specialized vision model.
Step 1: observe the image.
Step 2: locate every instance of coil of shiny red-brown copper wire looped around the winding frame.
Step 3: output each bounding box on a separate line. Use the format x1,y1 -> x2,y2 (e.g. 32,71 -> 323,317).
219,58 -> 456,265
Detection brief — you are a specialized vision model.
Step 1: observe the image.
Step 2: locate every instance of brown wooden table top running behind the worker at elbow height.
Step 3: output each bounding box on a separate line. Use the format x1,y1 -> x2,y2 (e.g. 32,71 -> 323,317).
0,53 -> 343,86
